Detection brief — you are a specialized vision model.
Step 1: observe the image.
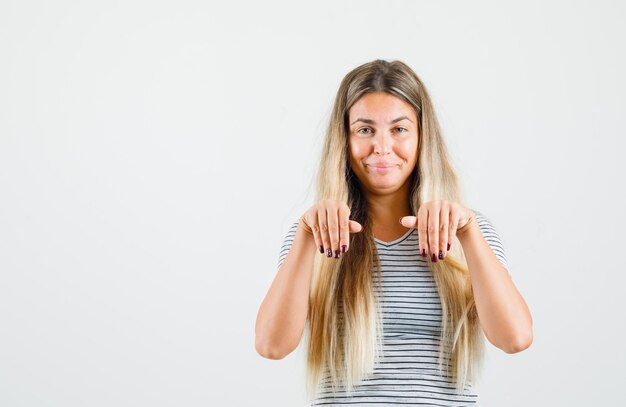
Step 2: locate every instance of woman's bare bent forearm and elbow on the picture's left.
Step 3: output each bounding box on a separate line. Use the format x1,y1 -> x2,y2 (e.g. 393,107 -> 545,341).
255,220 -> 317,359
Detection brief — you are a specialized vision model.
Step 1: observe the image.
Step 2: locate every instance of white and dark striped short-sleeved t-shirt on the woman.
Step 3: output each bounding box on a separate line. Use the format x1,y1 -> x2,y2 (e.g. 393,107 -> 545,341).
278,211 -> 508,406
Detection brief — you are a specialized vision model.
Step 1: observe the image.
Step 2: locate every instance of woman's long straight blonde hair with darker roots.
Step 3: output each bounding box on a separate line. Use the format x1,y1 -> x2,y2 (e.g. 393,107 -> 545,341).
306,60 -> 484,400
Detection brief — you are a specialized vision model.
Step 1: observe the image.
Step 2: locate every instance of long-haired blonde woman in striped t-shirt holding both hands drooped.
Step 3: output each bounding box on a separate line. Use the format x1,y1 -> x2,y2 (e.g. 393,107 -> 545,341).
256,60 -> 532,406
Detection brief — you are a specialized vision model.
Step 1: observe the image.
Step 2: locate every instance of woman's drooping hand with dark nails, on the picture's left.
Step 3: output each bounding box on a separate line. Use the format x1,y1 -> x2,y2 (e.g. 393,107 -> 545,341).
300,199 -> 363,259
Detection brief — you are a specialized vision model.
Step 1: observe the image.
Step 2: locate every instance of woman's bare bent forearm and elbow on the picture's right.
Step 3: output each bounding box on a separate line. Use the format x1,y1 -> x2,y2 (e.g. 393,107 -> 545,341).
457,222 -> 533,353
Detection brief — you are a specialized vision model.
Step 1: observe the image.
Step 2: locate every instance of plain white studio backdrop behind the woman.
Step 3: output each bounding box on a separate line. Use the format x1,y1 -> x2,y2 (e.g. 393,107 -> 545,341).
0,0 -> 626,407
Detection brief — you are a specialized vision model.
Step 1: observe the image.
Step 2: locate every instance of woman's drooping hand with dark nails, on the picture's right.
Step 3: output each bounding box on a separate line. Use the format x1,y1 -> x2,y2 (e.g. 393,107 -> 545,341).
400,200 -> 476,262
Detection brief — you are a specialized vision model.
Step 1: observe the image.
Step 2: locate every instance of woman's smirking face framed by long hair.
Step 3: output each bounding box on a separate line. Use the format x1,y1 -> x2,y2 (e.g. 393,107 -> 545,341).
348,92 -> 419,195
